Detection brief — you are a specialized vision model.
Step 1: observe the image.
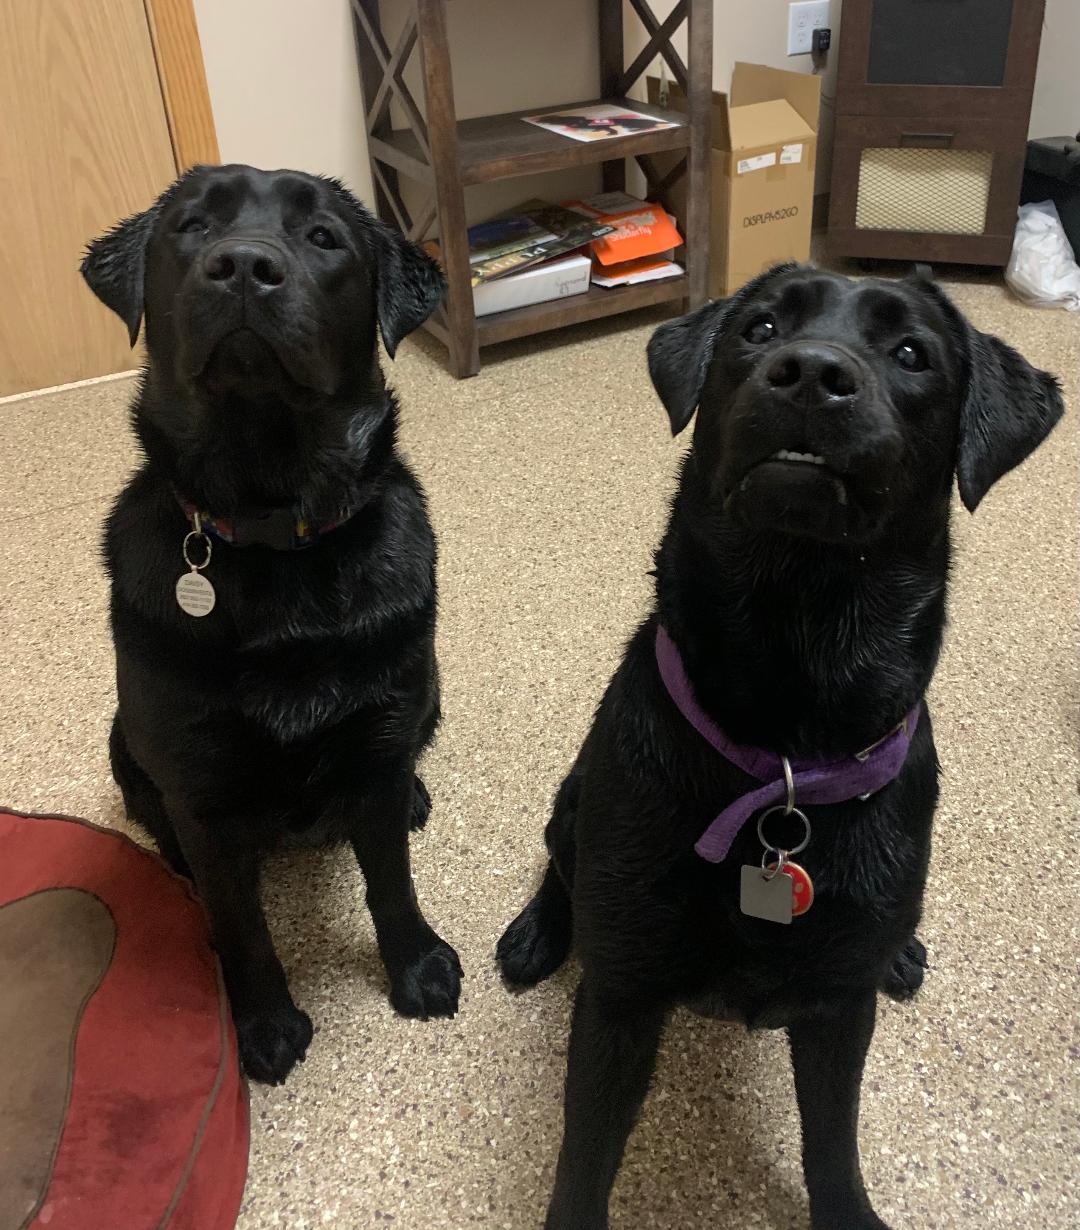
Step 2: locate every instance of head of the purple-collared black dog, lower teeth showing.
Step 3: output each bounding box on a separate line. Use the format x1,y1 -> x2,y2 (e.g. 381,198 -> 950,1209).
648,266 -> 1063,542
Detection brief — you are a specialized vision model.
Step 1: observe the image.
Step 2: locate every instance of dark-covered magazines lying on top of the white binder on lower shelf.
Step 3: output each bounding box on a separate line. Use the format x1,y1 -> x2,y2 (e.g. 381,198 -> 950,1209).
469,200 -> 614,287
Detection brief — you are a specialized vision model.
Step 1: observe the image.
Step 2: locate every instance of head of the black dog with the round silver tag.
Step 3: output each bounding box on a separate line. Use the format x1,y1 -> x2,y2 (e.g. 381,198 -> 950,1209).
82,166 -> 444,399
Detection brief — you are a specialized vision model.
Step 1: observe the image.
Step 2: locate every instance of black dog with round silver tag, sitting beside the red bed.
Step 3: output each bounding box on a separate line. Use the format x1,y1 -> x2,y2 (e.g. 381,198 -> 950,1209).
82,166 -> 461,1081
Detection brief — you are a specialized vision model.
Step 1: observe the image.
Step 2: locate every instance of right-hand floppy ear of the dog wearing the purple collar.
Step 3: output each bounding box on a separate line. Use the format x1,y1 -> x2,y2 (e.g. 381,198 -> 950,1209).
956,322 -> 1064,513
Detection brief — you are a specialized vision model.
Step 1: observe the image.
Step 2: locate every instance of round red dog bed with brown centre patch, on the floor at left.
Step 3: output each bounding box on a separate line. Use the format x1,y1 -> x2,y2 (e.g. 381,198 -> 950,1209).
0,811 -> 247,1230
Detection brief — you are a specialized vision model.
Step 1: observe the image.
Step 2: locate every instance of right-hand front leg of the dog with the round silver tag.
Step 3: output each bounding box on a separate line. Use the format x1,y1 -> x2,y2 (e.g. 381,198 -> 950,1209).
352,768 -> 461,1021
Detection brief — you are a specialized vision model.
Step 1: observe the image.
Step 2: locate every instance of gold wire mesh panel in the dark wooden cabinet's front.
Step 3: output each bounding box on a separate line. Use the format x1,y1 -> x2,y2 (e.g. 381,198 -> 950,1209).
855,148 -> 994,235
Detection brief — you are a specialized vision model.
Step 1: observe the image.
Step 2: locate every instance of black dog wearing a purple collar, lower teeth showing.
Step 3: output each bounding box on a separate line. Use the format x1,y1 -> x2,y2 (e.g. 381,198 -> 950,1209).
498,266 -> 1062,1230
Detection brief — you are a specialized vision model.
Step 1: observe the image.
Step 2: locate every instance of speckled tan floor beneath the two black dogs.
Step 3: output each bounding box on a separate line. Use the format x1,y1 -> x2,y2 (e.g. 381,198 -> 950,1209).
0,277 -> 1080,1230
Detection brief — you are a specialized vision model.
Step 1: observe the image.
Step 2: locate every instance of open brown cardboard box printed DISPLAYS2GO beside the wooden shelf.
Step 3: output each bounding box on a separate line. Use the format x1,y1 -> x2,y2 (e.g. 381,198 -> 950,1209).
648,63 -> 822,298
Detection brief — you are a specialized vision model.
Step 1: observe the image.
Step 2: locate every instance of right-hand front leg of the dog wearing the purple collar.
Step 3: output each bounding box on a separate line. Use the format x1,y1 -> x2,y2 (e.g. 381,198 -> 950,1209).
787,990 -> 887,1230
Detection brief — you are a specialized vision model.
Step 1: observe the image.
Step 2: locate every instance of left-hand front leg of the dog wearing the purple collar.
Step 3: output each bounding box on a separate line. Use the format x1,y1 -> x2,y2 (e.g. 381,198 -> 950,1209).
546,980 -> 665,1230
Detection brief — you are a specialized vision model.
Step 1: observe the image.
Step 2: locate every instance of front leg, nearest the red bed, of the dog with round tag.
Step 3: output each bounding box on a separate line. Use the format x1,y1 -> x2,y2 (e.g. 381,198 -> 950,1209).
169,806 -> 311,1085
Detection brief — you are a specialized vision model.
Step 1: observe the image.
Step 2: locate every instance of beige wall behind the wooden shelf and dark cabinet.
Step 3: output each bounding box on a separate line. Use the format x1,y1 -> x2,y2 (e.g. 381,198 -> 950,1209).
194,0 -> 1080,219
